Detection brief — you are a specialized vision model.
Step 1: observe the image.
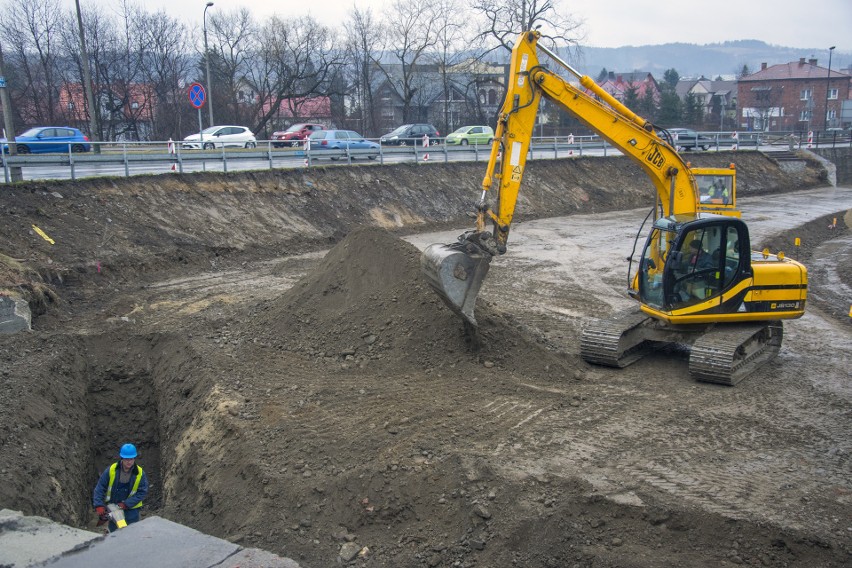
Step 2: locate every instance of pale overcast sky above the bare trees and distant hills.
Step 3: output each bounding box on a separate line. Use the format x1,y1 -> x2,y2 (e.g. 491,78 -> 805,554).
71,0 -> 852,54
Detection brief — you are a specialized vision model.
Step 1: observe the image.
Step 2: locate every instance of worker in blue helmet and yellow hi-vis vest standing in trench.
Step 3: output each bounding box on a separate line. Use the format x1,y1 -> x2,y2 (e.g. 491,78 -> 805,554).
92,444 -> 148,532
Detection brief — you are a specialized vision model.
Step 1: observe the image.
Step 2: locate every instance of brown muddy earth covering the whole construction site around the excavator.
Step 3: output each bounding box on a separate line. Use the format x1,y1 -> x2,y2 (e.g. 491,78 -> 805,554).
0,154 -> 852,568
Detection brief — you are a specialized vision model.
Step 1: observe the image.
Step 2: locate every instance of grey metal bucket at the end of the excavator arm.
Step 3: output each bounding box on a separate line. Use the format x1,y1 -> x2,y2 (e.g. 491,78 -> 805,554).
420,243 -> 491,326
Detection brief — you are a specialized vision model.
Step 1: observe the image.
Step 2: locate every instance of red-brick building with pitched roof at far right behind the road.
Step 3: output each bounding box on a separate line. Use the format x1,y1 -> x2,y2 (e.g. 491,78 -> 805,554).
737,57 -> 852,132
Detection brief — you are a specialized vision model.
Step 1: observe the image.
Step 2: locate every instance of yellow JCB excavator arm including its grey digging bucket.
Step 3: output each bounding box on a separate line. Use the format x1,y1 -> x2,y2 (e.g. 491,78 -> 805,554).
421,31 -> 698,325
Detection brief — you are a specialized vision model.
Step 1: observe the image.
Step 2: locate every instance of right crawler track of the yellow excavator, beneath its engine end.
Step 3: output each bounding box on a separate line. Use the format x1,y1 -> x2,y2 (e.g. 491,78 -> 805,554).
689,321 -> 784,385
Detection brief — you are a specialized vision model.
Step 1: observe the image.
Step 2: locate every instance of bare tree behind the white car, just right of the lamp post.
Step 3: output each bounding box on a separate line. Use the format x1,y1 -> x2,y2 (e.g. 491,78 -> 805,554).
207,7 -> 258,124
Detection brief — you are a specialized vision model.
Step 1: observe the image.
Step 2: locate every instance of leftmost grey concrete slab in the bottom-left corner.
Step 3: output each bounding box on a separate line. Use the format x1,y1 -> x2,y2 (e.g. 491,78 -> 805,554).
0,509 -> 103,568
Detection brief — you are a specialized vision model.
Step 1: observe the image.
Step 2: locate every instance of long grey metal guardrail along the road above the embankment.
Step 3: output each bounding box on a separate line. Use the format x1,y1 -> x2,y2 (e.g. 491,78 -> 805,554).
0,132 -> 852,183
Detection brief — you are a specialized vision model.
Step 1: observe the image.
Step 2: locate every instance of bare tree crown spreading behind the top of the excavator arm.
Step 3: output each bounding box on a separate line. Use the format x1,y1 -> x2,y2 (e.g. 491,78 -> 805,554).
473,0 -> 583,51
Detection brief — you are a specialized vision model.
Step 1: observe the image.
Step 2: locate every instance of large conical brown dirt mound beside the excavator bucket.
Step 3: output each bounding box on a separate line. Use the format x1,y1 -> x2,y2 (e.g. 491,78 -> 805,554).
250,227 -> 580,374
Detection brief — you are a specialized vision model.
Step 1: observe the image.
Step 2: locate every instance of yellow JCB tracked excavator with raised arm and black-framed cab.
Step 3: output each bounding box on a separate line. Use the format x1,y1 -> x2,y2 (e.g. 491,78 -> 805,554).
421,31 -> 807,385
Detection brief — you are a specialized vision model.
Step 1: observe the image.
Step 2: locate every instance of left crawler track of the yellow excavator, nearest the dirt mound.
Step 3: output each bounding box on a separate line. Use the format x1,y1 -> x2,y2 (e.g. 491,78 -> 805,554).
580,308 -> 654,369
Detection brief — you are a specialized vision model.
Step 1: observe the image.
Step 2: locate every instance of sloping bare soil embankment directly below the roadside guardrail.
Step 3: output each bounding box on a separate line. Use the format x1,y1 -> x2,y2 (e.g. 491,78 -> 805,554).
0,152 -> 826,284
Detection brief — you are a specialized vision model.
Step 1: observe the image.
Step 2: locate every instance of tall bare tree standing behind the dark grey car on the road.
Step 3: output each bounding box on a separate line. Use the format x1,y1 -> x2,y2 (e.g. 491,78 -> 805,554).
379,0 -> 437,122
